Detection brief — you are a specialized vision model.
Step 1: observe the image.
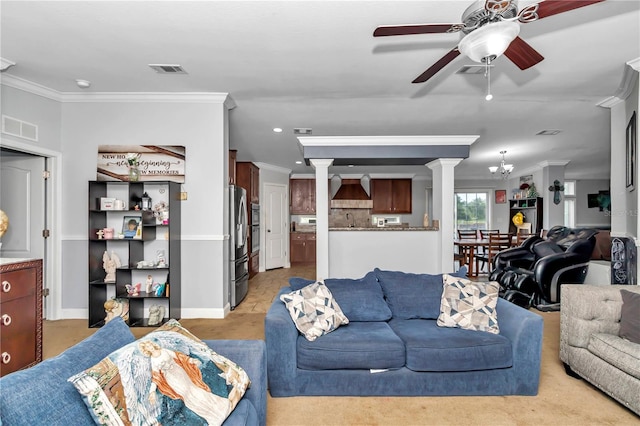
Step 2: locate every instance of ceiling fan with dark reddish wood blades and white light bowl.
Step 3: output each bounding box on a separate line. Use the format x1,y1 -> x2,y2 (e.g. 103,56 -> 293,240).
373,0 -> 604,83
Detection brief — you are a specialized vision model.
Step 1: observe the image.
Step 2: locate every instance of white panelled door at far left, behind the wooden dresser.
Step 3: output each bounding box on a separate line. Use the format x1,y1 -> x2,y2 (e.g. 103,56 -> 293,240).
0,150 -> 46,260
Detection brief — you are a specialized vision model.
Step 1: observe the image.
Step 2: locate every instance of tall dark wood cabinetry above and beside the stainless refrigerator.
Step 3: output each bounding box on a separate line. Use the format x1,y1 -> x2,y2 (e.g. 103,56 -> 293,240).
236,161 -> 260,279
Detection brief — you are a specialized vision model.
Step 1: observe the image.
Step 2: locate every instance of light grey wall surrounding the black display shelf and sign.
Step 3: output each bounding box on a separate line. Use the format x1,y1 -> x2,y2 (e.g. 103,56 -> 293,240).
62,95 -> 229,318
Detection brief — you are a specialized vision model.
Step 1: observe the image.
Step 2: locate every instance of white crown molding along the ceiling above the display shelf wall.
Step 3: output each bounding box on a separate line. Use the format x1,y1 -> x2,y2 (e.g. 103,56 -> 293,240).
0,74 -> 236,109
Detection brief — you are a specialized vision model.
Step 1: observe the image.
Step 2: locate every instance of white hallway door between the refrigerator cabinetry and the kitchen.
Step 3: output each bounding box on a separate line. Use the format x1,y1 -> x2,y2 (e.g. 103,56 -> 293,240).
264,183 -> 288,269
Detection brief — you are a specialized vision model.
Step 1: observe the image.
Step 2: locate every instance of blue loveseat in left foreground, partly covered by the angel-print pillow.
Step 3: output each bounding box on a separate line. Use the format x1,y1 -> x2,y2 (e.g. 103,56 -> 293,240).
0,318 -> 267,426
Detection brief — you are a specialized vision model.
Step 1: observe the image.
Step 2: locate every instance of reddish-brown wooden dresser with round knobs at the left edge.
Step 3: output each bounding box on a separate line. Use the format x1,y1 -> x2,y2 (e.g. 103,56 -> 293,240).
0,258 -> 42,376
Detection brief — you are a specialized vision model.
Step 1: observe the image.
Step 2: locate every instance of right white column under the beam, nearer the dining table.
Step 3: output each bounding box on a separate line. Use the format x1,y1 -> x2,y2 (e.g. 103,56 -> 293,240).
427,158 -> 462,273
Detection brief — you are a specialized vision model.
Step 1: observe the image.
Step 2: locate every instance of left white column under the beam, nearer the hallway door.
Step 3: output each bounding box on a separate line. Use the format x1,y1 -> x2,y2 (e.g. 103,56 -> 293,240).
311,158 -> 333,281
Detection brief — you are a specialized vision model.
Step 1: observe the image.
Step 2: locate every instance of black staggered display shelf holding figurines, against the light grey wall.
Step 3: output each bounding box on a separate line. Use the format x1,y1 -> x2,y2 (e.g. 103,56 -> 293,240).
88,181 -> 181,327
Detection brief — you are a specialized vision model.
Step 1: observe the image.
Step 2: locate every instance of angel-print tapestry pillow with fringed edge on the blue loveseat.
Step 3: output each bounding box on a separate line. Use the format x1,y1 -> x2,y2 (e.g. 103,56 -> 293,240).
69,320 -> 250,424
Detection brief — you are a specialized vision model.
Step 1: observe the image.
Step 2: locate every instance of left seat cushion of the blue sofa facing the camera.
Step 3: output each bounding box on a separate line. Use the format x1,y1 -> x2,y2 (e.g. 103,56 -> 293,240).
296,321 -> 405,370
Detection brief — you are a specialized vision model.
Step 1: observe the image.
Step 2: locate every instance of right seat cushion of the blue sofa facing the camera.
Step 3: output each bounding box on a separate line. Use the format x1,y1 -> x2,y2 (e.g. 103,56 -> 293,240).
389,318 -> 513,371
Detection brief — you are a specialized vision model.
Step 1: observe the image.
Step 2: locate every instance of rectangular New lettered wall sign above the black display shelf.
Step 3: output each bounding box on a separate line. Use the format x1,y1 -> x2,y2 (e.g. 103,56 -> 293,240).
97,145 -> 186,183
